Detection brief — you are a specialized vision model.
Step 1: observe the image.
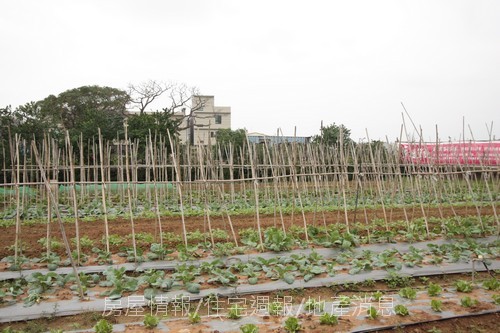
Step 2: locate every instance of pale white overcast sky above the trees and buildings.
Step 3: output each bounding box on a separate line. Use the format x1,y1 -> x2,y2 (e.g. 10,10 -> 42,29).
0,0 -> 500,141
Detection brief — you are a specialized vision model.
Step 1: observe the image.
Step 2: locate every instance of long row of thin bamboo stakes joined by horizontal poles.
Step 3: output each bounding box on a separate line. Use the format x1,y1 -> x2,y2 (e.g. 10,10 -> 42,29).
0,126 -> 500,298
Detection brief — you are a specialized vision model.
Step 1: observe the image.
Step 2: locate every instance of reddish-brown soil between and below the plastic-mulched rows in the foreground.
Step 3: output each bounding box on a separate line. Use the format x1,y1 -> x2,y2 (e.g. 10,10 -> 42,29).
0,272 -> 498,333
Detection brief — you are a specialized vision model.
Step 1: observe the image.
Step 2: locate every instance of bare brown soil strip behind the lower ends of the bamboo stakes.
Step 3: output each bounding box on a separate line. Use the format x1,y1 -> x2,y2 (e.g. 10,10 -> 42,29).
0,206 -> 493,258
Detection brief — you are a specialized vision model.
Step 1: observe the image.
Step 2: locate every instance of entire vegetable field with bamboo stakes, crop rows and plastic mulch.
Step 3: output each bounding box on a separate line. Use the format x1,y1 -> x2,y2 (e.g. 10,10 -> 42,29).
0,136 -> 500,332
